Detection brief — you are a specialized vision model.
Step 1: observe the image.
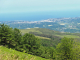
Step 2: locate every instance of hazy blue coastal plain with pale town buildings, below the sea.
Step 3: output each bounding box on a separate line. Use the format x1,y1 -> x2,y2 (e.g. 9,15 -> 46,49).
0,17 -> 80,33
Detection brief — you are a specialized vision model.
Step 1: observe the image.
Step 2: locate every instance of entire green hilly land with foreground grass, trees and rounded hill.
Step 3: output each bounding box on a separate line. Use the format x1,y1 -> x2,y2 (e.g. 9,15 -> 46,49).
0,24 -> 80,60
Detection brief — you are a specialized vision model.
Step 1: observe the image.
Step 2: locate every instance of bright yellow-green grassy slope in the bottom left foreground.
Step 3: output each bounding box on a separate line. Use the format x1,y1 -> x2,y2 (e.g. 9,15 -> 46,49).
0,46 -> 49,60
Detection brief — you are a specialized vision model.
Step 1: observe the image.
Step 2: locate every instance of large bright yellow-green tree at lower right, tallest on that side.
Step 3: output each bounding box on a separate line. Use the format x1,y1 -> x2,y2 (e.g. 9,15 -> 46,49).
57,37 -> 73,60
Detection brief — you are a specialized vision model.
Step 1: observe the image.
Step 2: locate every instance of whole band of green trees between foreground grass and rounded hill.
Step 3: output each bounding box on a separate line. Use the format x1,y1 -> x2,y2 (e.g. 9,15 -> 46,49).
0,24 -> 80,60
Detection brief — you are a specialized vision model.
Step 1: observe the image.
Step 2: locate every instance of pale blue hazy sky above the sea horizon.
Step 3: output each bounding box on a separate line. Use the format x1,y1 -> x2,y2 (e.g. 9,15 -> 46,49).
0,0 -> 80,13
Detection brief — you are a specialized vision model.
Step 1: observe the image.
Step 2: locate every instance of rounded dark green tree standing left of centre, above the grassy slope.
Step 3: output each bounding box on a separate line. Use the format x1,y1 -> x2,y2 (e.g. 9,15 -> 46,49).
22,33 -> 40,54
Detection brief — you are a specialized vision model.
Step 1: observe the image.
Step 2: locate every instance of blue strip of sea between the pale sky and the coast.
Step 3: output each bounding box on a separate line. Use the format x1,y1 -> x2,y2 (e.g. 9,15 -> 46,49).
0,11 -> 80,21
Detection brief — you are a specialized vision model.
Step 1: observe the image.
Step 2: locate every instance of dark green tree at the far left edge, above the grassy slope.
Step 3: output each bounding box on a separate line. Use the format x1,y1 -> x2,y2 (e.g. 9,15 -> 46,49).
0,24 -> 13,46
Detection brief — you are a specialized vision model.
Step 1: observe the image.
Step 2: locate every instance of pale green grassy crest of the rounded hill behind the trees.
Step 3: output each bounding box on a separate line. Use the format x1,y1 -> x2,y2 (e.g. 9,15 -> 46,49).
21,28 -> 80,38
